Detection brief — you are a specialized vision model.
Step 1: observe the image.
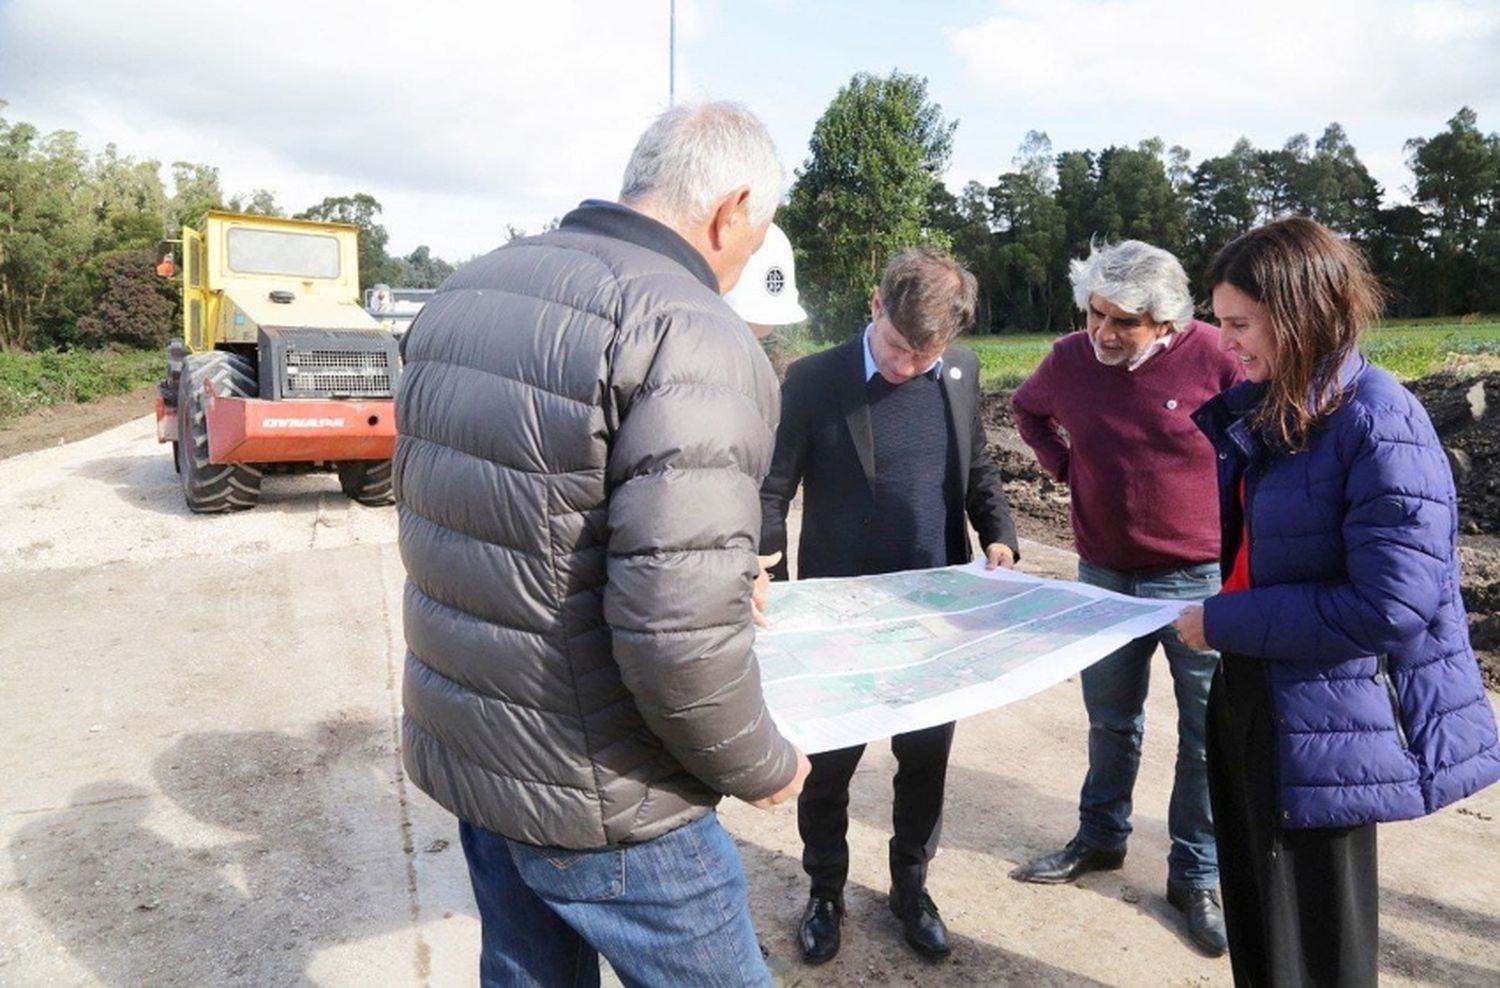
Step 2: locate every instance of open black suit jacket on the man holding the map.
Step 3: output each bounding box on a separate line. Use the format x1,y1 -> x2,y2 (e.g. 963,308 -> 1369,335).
761,333 -> 1020,580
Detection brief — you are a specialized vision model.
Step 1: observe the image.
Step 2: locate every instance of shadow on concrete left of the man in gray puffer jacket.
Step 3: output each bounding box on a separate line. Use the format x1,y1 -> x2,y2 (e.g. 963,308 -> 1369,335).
9,718 -> 456,985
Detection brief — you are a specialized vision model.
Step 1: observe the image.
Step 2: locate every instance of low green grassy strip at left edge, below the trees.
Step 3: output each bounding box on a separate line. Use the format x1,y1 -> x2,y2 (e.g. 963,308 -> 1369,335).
0,349 -> 167,426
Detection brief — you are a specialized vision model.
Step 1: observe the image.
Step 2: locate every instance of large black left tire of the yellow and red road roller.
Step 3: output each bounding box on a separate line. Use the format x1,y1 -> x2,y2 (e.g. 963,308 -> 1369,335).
177,351 -> 261,514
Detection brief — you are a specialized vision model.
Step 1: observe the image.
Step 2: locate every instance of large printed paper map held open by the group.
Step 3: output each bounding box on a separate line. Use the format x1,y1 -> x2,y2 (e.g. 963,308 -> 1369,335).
756,562 -> 1184,753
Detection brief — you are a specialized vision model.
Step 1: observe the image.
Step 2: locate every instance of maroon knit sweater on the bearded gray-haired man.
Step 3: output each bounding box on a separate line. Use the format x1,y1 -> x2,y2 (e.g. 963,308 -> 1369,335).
1011,319 -> 1242,570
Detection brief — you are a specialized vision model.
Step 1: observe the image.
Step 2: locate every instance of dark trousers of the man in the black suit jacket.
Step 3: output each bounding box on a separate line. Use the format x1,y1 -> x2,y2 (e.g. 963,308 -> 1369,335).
797,723 -> 953,900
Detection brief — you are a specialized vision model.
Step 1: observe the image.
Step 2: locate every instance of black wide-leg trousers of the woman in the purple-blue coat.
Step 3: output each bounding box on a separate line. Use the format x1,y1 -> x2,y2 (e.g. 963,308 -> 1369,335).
1208,655 -> 1380,988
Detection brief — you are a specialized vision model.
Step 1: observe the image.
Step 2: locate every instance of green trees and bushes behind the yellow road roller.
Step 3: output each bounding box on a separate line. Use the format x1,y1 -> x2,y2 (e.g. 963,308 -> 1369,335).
0,102 -> 453,351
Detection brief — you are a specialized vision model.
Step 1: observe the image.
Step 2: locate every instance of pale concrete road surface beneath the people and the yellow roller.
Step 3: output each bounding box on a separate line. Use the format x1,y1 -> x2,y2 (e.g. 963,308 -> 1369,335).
0,418 -> 1500,987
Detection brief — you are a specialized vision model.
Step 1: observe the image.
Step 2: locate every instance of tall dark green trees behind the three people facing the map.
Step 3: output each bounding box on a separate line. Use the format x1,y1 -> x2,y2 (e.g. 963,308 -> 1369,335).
780,72 -> 1500,339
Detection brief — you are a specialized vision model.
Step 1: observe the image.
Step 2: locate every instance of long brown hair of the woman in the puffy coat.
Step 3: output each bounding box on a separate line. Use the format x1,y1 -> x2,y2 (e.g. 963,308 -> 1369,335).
1205,216 -> 1385,450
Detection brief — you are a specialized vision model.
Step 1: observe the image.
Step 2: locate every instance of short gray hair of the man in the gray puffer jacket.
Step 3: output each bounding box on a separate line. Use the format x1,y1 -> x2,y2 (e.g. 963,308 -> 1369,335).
620,102 -> 786,225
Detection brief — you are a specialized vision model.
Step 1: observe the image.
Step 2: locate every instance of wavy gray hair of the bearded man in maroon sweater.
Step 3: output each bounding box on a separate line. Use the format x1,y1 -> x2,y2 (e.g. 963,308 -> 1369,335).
1068,240 -> 1193,330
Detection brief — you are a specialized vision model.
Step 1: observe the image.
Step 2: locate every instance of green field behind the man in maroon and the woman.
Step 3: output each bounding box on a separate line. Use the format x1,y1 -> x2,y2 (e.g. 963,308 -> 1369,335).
962,316 -> 1500,390
